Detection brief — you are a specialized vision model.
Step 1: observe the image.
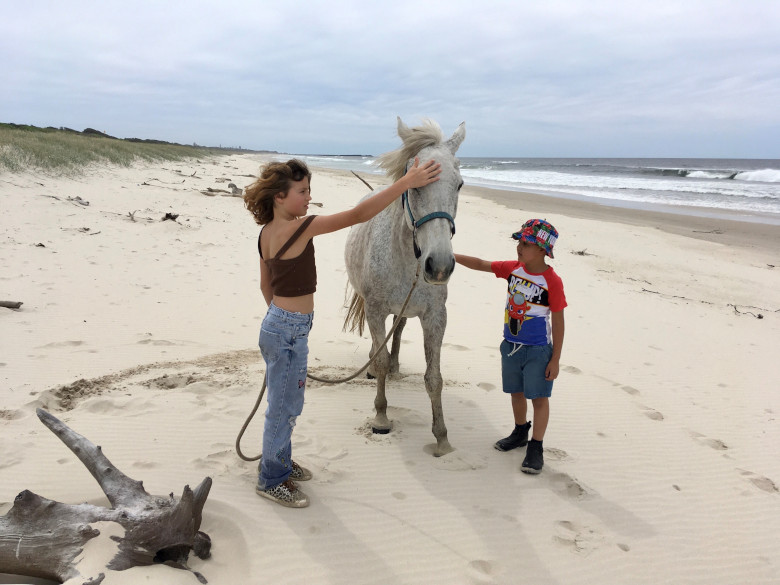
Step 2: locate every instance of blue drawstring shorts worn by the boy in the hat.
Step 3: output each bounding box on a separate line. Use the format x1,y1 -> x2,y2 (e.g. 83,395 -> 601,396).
499,339 -> 552,399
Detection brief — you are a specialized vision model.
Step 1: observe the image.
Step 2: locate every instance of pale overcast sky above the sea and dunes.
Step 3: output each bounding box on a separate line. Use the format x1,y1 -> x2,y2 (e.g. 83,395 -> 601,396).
0,0 -> 780,159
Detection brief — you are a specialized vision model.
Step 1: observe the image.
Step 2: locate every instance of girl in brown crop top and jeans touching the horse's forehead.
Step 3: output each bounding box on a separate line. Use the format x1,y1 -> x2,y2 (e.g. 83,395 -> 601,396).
244,159 -> 441,508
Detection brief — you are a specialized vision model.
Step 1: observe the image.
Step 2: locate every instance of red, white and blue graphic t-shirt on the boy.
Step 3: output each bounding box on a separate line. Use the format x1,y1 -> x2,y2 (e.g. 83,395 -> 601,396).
490,260 -> 566,345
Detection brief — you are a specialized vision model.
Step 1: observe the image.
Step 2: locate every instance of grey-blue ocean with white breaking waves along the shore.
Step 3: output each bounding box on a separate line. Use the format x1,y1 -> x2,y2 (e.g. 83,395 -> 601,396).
298,155 -> 780,225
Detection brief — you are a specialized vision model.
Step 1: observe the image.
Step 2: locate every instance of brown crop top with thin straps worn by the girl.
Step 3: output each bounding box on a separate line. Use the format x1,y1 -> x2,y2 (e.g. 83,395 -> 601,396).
257,215 -> 317,297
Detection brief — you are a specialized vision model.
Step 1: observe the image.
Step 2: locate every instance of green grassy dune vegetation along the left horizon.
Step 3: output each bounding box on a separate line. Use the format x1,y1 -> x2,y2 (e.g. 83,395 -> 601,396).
0,123 -> 252,175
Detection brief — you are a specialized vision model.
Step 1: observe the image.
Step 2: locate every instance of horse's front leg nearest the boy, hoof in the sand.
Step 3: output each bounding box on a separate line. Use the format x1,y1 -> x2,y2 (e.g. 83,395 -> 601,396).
421,303 -> 453,457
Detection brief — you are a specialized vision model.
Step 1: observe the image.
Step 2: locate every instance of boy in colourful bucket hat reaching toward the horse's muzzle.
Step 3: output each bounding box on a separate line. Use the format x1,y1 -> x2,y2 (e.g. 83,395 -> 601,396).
455,219 -> 566,474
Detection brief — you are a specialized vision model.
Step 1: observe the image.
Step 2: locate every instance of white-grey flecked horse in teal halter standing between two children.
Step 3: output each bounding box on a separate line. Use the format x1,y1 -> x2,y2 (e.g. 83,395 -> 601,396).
345,118 -> 466,456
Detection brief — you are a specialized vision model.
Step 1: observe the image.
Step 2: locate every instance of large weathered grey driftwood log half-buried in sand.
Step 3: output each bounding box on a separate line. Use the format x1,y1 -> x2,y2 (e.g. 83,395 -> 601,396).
0,408 -> 211,585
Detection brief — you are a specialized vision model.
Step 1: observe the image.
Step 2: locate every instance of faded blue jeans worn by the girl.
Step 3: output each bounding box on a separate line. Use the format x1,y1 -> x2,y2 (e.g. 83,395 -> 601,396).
257,303 -> 314,489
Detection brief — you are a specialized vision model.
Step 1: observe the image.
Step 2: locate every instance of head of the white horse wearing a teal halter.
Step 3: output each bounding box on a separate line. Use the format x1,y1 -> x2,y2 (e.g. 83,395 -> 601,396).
379,118 -> 466,284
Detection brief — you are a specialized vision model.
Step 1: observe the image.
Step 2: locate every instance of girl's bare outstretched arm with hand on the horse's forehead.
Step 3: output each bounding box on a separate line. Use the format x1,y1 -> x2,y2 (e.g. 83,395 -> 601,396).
305,158 -> 441,238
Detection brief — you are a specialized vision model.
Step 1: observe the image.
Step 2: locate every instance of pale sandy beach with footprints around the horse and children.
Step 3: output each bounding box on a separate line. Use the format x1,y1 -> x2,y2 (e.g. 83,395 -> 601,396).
0,155 -> 780,585
